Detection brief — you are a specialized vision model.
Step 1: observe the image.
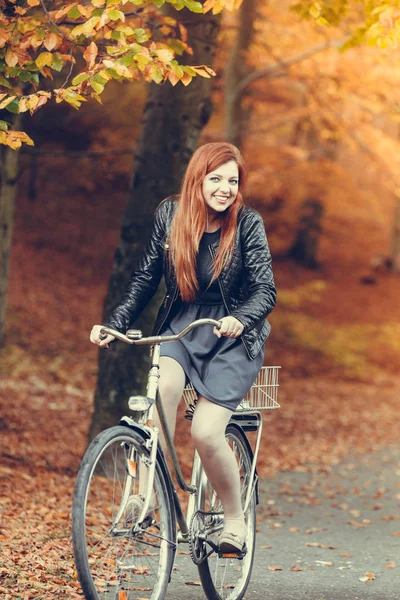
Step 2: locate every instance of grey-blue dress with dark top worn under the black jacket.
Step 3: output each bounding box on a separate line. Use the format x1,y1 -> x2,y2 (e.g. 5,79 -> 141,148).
161,230 -> 264,411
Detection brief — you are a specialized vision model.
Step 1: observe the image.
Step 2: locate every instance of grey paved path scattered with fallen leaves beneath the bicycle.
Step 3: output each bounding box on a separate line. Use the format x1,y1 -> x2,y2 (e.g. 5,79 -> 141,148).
167,444 -> 400,600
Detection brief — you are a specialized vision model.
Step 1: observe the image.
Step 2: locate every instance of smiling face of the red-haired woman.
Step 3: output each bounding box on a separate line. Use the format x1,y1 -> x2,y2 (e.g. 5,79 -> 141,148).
203,160 -> 239,219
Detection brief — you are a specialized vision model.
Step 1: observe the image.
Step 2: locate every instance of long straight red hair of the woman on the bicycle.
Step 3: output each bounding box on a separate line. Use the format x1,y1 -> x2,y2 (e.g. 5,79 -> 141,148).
171,142 -> 246,302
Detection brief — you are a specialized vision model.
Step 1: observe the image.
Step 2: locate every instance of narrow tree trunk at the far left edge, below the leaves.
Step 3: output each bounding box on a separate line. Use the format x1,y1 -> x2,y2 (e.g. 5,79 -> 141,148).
0,113 -> 19,348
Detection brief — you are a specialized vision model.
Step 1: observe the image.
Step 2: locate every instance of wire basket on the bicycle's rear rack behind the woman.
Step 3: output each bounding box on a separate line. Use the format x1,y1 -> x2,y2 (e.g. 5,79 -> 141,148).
183,366 -> 280,411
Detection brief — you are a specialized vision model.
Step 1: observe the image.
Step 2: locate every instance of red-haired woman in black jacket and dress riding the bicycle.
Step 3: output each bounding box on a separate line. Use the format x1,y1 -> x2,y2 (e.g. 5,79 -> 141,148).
90,143 -> 276,552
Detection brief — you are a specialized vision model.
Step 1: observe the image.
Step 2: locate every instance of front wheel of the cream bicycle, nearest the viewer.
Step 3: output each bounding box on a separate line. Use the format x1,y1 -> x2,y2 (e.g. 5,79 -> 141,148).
72,426 -> 176,600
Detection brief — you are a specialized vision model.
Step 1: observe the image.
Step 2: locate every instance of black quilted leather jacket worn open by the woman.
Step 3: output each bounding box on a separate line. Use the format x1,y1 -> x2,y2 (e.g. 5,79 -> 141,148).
105,198 -> 276,359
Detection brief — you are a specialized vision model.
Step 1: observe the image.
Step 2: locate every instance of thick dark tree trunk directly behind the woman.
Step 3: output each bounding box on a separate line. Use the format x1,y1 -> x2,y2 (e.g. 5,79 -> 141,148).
89,10 -> 219,439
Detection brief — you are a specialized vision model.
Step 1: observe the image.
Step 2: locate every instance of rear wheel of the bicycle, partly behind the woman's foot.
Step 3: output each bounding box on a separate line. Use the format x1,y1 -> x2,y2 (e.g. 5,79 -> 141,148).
197,424 -> 256,600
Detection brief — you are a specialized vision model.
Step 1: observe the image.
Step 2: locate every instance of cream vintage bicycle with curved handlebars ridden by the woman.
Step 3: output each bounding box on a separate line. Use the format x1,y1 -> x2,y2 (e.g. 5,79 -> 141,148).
72,319 -> 280,600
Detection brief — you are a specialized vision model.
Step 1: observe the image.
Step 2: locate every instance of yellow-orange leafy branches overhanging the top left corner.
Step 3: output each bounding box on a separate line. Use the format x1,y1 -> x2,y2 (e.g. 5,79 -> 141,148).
0,0 -> 222,150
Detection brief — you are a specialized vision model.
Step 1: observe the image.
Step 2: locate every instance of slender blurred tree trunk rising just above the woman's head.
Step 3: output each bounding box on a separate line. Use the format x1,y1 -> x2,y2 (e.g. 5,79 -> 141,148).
225,0 -> 257,147
